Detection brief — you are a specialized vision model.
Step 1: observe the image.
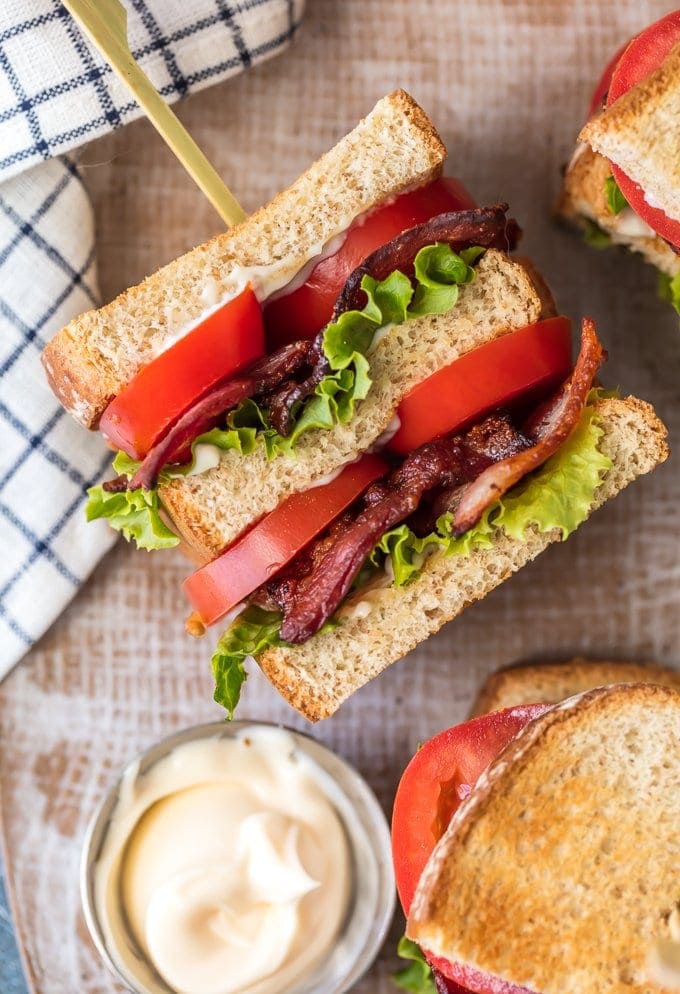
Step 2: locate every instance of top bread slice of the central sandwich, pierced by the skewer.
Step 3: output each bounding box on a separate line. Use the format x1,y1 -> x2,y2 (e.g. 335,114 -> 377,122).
43,90 -> 446,428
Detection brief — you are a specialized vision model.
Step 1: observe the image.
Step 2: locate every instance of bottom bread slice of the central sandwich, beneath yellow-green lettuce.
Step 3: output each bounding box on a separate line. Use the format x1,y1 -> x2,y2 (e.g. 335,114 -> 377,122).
258,397 -> 668,721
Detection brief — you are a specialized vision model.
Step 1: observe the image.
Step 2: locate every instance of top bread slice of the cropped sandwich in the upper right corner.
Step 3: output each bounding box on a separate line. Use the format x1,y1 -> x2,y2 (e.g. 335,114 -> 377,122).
579,45 -> 680,221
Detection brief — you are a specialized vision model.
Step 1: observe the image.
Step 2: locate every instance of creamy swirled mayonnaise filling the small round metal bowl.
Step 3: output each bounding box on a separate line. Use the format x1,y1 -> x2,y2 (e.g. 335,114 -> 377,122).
95,726 -> 352,994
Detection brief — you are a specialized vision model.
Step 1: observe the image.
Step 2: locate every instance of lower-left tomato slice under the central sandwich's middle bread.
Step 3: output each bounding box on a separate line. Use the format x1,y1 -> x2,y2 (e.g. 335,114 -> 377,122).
184,455 -> 389,625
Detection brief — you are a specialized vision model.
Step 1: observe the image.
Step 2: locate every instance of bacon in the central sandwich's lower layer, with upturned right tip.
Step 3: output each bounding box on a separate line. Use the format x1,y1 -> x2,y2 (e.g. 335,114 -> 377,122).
253,319 -> 605,643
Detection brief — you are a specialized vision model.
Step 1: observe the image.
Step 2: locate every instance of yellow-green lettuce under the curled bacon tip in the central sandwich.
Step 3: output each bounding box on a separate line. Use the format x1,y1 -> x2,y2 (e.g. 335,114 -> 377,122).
371,390 -> 612,586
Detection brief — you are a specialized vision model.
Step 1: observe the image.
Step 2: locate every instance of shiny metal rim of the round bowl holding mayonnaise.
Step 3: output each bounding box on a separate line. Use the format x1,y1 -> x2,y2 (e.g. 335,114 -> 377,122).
80,719 -> 396,994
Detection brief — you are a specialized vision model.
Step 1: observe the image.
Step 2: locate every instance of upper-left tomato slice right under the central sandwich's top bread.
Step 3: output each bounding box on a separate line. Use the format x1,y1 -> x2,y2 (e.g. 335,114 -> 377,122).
99,286 -> 265,459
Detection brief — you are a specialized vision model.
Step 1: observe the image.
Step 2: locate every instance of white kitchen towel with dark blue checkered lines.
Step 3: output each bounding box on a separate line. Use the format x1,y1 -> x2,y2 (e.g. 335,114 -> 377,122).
0,0 -> 304,678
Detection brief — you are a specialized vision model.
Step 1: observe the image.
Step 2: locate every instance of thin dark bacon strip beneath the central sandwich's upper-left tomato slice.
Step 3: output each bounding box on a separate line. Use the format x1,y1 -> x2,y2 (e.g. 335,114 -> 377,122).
104,341 -> 312,493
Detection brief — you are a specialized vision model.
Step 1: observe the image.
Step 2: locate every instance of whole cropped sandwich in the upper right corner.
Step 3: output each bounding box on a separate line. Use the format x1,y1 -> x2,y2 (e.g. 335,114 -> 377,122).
558,11 -> 680,300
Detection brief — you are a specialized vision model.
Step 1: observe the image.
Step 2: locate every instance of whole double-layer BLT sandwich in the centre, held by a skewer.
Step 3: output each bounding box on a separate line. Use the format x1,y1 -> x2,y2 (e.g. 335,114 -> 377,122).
44,91 -> 667,720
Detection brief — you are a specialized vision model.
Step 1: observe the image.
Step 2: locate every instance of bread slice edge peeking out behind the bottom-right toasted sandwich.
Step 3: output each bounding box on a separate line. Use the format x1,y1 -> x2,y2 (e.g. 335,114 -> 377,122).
470,656 -> 680,718
